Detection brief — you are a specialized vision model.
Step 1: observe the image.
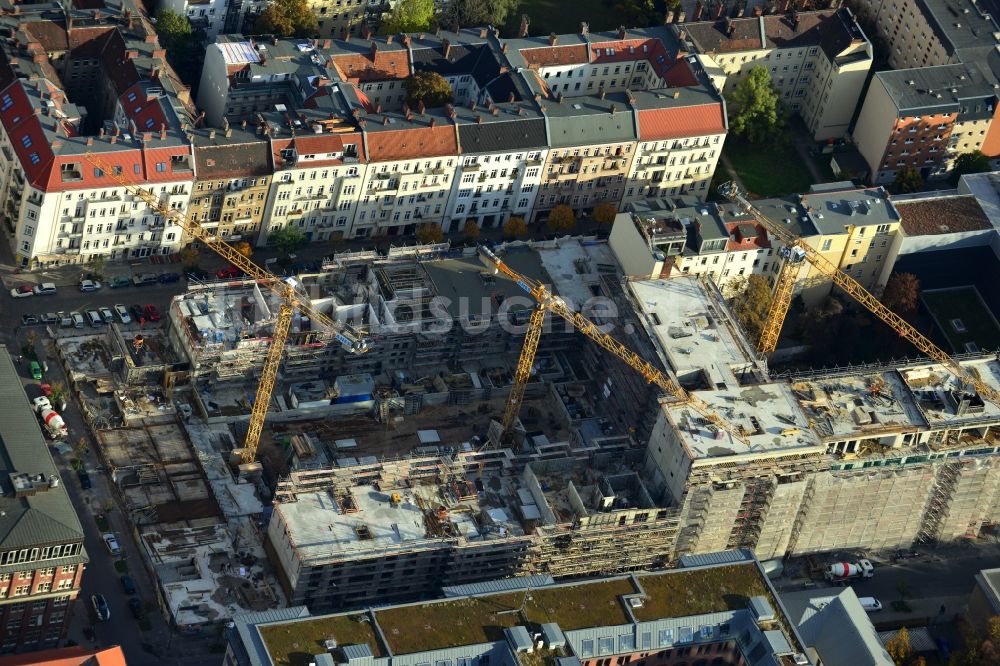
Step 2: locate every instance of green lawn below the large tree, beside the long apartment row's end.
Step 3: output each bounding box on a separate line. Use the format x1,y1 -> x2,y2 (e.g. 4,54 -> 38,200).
722,136 -> 812,197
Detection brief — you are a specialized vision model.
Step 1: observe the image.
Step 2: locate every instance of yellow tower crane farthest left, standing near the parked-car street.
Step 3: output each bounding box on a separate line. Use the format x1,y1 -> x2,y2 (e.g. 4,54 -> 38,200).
85,151 -> 368,466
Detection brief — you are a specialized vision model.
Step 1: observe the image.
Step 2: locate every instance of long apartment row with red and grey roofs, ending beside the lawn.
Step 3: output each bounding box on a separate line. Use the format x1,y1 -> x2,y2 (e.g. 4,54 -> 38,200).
199,26 -> 726,243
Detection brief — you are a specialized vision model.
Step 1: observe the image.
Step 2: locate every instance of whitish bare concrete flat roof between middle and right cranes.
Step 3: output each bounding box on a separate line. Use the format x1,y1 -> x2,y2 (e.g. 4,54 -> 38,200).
629,276 -> 754,388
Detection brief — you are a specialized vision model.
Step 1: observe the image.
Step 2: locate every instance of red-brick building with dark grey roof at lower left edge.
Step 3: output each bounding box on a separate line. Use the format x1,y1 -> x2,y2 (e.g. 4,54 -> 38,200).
0,351 -> 88,652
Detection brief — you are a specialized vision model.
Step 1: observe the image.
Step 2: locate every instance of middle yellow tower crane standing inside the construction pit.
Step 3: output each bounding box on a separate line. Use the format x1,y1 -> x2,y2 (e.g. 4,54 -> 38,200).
478,245 -> 748,444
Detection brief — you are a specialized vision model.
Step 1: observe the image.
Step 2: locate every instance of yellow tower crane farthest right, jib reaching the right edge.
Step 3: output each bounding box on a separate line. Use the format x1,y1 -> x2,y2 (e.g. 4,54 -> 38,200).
719,181 -> 1000,405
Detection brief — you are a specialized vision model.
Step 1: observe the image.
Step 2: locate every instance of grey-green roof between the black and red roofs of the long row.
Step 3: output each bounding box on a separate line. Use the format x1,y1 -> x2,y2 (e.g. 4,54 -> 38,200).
545,93 -> 639,148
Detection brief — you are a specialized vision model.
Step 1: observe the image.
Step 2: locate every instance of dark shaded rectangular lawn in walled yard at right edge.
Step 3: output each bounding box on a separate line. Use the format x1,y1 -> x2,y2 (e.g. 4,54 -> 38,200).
920,286 -> 1000,354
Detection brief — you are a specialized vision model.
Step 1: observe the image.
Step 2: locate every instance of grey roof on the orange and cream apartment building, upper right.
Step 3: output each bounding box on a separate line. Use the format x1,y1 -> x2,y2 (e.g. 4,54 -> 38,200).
875,65 -> 996,119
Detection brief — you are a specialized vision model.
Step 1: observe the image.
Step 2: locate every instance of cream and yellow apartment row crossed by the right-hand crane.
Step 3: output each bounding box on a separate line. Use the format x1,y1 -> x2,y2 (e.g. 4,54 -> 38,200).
610,183 -> 901,305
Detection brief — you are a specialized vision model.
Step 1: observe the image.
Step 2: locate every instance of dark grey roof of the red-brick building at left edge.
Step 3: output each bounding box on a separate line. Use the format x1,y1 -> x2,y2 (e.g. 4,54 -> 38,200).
0,350 -> 86,558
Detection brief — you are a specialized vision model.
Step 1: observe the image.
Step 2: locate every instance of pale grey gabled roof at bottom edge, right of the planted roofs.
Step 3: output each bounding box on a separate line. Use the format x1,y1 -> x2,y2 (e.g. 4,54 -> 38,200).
781,587 -> 893,666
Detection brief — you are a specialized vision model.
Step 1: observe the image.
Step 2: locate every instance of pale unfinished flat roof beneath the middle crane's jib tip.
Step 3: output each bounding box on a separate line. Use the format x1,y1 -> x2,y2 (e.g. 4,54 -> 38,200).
663,382 -> 825,460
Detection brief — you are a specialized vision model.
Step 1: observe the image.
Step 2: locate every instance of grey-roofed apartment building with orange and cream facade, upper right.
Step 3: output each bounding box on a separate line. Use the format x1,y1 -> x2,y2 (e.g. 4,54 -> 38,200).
854,64 -> 1000,183
